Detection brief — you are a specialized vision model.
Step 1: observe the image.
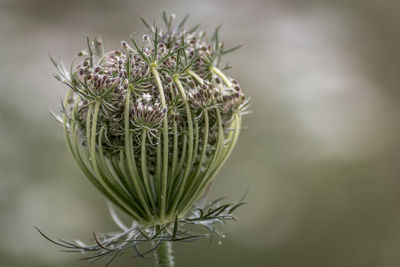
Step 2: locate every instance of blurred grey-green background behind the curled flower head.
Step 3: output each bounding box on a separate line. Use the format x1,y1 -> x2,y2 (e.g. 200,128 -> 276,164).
0,0 -> 400,267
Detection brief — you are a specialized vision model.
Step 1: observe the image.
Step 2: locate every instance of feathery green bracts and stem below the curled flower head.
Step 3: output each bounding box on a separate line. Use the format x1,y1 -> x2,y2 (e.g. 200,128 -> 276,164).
36,198 -> 245,266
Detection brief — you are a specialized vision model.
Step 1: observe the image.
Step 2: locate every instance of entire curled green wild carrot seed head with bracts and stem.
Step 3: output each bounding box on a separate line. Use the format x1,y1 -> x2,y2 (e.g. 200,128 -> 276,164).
40,12 -> 249,266
